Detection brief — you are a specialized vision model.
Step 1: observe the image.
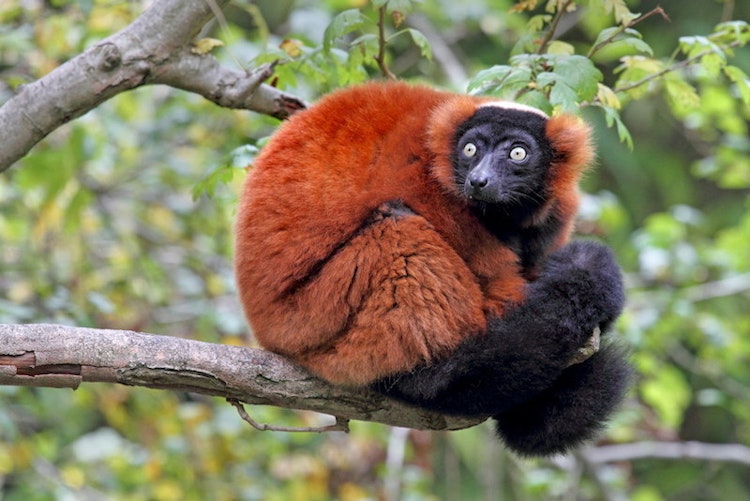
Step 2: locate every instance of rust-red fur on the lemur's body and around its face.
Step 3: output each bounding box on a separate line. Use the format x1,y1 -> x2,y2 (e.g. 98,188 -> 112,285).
236,83 -> 591,385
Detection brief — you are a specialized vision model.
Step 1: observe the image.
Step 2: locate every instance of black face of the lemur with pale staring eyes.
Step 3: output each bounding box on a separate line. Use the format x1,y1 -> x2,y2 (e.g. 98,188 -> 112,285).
453,106 -> 552,221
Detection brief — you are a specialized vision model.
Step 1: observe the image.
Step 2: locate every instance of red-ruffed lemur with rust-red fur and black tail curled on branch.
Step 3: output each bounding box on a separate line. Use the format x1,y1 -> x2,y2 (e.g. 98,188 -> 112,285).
236,83 -> 629,455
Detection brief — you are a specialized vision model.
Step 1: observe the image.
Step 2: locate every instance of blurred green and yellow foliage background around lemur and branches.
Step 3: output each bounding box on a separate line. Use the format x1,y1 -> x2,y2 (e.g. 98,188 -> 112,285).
0,0 -> 750,501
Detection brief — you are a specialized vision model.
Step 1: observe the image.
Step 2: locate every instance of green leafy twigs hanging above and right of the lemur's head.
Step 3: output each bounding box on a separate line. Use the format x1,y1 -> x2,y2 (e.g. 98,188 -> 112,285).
468,0 -> 750,148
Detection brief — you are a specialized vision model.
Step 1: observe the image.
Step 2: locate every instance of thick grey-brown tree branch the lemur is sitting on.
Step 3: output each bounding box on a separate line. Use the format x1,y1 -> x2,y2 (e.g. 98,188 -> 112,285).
0,324 -> 484,430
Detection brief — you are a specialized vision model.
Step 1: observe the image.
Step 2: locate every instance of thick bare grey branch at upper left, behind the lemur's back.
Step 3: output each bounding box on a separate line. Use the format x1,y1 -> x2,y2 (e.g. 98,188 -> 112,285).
0,0 -> 304,172
